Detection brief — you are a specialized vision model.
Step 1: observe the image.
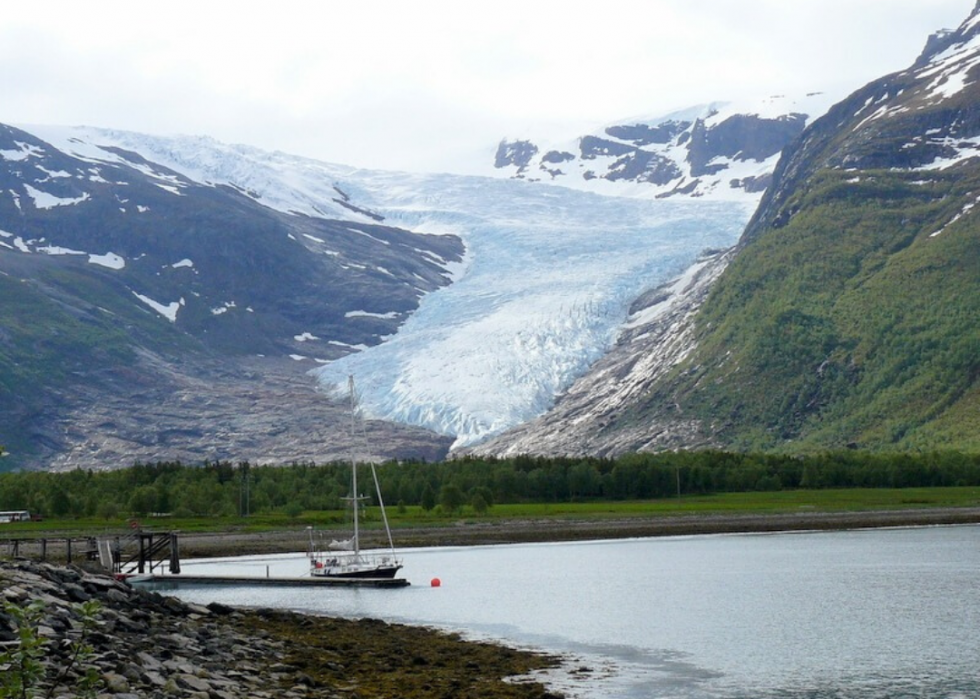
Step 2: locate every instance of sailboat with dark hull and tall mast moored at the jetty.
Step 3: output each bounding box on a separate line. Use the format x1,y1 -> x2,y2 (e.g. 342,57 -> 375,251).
309,376 -> 402,579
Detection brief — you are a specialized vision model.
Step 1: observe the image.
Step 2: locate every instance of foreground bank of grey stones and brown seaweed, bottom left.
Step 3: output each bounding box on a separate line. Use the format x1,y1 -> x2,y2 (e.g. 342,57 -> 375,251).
0,561 -> 560,699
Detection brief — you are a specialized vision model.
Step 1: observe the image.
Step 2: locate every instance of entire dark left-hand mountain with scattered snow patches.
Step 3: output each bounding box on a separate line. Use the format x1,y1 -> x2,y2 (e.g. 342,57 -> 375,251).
0,126 -> 464,468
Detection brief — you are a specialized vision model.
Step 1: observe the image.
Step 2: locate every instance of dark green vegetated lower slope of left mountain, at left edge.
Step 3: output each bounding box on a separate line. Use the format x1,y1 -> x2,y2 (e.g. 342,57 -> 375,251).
0,264 -> 197,470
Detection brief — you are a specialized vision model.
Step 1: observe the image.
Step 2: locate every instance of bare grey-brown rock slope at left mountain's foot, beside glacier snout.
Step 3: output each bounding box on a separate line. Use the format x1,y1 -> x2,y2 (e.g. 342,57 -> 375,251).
34,352 -> 452,471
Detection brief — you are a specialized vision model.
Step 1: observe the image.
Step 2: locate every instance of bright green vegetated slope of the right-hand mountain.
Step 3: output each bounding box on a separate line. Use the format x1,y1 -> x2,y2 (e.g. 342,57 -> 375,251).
676,171 -> 980,450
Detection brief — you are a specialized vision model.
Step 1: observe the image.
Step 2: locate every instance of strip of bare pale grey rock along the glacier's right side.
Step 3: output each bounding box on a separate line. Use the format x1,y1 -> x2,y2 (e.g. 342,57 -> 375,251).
472,251 -> 733,456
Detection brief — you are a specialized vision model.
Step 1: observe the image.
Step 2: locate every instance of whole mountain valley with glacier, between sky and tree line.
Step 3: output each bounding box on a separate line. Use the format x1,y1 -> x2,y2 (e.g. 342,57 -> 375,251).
0,4 -> 980,470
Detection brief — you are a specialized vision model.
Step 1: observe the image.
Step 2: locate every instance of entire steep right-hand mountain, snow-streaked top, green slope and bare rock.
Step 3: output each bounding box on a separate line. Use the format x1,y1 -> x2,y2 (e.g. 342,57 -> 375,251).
480,6 -> 980,454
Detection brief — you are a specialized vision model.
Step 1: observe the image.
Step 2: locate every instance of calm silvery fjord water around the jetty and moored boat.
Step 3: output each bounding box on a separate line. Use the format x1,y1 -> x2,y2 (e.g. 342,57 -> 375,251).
175,526 -> 980,699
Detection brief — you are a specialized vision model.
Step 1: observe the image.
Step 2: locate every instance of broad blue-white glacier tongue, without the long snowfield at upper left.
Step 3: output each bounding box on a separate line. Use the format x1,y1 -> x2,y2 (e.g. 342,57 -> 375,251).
315,172 -> 752,447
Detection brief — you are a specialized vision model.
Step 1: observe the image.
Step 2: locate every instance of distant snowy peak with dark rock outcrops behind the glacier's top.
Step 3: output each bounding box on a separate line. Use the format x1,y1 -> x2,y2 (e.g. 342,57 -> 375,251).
493,92 -> 832,201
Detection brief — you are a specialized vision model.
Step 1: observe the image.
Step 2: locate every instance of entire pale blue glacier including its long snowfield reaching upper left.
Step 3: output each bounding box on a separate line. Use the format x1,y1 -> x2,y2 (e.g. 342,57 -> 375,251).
24,126 -> 758,447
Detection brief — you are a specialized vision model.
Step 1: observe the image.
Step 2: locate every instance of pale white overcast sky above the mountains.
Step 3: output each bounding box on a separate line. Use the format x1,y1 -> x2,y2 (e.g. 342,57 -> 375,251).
0,0 -> 975,171
